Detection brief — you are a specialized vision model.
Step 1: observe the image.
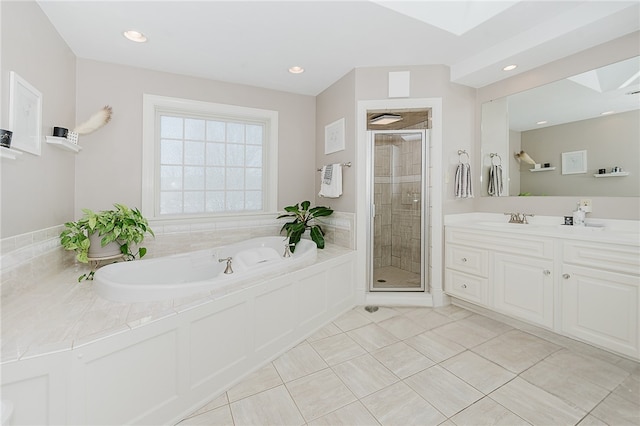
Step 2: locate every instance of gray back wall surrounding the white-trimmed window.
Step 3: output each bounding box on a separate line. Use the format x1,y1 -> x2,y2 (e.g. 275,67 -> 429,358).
75,59 -> 315,214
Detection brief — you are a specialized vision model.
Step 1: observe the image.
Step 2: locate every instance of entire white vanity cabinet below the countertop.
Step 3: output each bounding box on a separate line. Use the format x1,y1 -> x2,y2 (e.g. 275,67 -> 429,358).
445,227 -> 640,359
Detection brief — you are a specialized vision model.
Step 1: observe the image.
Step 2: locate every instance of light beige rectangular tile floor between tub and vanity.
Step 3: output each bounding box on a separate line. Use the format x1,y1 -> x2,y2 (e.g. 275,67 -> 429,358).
179,305 -> 640,426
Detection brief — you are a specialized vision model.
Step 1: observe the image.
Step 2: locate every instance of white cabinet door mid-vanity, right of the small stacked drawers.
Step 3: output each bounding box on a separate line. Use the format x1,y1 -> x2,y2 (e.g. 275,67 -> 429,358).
493,253 -> 553,328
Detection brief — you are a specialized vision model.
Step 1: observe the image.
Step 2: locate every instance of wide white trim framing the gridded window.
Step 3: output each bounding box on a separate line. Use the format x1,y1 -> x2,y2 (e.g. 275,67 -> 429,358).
142,94 -> 278,220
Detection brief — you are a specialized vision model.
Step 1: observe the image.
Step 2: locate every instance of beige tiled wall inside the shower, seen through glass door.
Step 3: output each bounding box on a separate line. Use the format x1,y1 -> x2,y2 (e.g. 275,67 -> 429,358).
374,135 -> 422,273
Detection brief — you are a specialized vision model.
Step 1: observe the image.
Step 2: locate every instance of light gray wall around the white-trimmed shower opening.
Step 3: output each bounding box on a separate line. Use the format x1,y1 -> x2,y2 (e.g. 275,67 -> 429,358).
316,65 -> 475,214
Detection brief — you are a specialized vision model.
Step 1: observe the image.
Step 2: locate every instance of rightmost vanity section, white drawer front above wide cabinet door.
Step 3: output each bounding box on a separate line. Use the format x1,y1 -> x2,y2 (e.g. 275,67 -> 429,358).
560,241 -> 640,358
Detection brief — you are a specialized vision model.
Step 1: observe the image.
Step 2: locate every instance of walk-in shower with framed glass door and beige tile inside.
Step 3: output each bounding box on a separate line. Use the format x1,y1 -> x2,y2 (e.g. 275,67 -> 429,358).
369,130 -> 429,291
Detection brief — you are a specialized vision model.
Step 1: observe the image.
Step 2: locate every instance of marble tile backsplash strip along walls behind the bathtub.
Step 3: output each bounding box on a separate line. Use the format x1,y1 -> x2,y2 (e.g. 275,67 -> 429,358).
0,212 -> 355,298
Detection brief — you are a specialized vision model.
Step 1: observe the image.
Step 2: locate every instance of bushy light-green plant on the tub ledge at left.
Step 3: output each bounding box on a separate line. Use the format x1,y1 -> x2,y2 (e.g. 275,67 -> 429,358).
60,204 -> 154,280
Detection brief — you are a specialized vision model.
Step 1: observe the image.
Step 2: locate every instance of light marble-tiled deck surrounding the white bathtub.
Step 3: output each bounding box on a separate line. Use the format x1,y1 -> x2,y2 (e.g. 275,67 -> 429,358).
2,245 -> 351,362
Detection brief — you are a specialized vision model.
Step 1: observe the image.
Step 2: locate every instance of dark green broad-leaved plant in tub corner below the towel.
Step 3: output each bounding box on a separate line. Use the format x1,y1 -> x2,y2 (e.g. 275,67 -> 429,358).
278,201 -> 333,252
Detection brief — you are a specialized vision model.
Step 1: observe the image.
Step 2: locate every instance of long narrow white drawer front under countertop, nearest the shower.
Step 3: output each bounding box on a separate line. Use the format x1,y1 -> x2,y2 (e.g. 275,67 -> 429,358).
445,225 -> 553,259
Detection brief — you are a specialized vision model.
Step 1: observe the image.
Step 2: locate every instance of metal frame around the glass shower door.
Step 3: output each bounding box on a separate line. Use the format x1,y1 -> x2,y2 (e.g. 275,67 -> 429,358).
367,129 -> 430,293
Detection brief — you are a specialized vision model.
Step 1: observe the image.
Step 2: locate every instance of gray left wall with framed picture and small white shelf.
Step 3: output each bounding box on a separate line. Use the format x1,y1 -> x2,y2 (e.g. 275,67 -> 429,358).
0,1 -> 76,238
